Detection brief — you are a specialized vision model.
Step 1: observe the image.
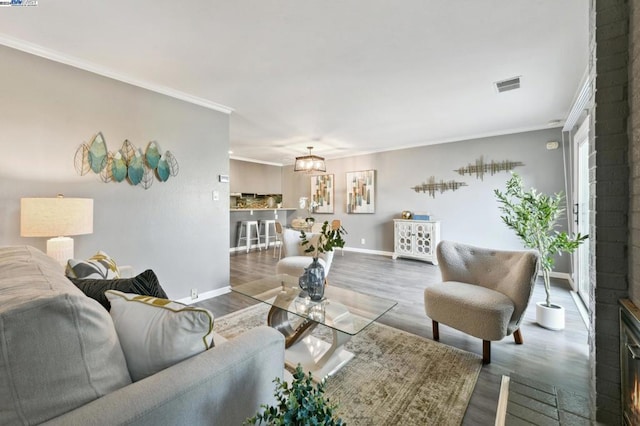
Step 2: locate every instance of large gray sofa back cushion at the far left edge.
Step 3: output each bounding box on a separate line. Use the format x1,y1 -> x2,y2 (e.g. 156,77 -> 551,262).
0,246 -> 131,424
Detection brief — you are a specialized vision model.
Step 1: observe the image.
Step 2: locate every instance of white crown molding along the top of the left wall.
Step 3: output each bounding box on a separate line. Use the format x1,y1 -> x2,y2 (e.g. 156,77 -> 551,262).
0,33 -> 233,114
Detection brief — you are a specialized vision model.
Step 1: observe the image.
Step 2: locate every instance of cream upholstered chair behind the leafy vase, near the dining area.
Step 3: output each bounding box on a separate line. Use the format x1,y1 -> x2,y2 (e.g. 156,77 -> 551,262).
276,229 -> 333,277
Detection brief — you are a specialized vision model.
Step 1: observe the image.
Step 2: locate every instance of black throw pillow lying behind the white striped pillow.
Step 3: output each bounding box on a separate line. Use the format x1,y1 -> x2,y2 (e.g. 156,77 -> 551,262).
68,269 -> 167,311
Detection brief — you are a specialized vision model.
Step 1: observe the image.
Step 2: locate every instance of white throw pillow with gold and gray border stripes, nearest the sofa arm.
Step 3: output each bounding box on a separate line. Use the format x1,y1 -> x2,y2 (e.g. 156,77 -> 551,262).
105,290 -> 213,381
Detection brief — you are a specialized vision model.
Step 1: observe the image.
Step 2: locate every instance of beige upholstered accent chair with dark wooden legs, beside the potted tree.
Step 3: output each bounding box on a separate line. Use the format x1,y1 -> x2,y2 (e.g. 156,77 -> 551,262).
424,241 -> 540,364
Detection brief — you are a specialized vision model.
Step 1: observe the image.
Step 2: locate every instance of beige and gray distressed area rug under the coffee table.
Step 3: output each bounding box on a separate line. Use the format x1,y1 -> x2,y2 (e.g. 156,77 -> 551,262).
214,304 -> 482,426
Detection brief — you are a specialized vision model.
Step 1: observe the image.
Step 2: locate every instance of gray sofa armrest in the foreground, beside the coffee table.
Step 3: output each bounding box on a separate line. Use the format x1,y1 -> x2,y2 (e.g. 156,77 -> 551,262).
45,326 -> 284,426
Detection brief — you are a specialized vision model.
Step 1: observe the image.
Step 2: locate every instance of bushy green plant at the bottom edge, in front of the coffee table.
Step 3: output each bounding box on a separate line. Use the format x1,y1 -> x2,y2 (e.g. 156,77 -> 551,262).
245,364 -> 346,426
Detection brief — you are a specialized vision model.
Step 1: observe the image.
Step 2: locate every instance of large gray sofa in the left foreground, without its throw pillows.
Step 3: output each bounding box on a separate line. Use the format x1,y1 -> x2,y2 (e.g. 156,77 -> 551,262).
0,246 -> 284,425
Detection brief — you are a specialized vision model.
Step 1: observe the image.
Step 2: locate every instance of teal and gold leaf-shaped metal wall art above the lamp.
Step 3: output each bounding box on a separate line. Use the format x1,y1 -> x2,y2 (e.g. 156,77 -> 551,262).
74,132 -> 180,189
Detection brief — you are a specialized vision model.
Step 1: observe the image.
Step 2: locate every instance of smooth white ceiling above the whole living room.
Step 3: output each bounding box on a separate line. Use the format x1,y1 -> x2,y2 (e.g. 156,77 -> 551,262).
0,0 -> 588,164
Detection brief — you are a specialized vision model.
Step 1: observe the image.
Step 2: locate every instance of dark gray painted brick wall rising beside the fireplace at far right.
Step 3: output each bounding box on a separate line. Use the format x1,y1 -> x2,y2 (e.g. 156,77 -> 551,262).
590,0 -> 640,424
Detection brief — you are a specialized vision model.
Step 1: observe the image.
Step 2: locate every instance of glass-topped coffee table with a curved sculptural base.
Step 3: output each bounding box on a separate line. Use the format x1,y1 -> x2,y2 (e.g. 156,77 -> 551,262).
231,275 -> 397,380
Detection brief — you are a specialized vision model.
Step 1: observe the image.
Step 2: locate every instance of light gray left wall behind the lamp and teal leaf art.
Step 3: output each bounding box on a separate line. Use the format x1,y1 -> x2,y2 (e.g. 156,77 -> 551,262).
0,46 -> 229,298
